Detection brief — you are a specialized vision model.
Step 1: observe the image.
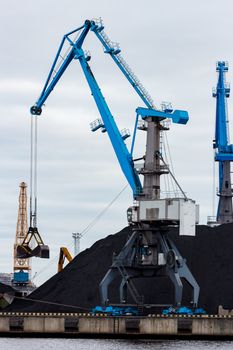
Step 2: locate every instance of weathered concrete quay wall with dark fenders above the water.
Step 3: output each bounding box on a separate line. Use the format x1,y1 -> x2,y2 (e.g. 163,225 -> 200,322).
0,313 -> 233,338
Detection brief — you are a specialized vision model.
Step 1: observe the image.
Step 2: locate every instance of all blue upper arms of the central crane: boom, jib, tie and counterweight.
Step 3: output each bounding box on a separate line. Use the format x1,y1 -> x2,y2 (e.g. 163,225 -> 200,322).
31,20 -> 188,197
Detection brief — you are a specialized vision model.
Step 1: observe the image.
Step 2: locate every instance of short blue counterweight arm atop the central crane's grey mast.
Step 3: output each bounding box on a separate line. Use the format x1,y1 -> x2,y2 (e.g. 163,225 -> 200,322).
136,107 -> 189,124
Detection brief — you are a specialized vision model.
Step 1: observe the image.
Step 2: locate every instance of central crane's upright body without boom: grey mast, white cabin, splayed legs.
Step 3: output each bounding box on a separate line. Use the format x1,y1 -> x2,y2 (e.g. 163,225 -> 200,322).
100,107 -> 200,307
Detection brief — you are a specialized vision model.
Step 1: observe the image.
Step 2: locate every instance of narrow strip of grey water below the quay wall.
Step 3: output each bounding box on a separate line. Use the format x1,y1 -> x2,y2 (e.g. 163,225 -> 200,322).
0,338 -> 233,350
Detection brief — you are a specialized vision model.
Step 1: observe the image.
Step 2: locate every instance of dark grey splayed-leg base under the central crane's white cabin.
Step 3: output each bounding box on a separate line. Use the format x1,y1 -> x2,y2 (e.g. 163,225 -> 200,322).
99,226 -> 200,307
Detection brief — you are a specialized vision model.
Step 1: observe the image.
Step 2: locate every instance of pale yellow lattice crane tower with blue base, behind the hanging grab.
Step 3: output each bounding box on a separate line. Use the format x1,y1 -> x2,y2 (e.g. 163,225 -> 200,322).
13,182 -> 31,287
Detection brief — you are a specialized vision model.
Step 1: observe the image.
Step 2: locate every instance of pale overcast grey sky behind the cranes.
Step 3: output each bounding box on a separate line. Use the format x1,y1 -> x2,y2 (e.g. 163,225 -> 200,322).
0,0 -> 233,284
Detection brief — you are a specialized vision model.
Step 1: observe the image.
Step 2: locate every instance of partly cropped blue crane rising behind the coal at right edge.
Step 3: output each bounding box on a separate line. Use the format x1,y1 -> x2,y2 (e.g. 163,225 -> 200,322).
213,61 -> 233,224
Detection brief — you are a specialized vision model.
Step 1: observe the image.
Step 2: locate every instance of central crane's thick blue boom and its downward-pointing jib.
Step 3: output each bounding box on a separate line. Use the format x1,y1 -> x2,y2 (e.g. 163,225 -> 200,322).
31,20 -> 142,197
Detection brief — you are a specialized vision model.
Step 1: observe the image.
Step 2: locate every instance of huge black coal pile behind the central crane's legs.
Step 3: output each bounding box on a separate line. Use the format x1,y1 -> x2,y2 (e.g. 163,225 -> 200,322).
7,224 -> 233,313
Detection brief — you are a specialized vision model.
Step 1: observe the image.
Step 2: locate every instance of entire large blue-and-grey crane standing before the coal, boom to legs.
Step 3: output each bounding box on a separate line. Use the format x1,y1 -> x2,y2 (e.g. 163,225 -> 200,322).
31,19 -> 199,306
